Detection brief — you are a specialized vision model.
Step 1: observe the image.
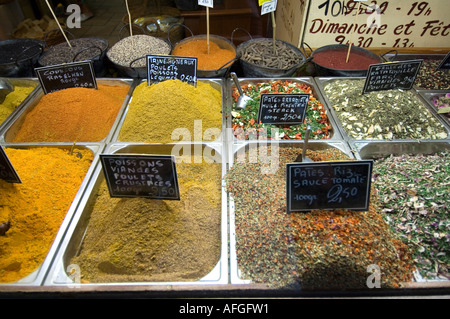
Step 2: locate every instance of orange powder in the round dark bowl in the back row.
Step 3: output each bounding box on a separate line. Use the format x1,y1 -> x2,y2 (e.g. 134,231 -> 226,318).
172,40 -> 236,70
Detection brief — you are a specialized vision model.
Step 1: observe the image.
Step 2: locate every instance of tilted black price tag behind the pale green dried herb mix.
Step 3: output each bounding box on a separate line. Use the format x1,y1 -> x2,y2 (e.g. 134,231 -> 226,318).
363,60 -> 423,94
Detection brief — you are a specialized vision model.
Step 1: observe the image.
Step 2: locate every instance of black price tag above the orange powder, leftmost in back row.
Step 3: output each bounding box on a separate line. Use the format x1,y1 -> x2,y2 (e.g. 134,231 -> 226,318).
35,61 -> 97,94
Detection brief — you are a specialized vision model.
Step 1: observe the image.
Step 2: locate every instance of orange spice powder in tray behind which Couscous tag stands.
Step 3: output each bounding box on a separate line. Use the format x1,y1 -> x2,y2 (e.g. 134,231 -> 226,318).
12,84 -> 129,142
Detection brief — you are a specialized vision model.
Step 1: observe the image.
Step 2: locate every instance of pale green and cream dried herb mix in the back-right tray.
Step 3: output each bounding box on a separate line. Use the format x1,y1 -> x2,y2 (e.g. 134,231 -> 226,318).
324,80 -> 447,140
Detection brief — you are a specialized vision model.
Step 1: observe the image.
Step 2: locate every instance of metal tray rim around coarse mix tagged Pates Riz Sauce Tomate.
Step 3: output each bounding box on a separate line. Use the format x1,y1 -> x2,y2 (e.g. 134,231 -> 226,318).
228,141 -> 355,284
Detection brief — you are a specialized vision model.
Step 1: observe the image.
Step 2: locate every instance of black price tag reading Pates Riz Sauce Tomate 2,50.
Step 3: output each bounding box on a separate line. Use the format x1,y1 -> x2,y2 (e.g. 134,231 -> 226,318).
286,160 -> 373,213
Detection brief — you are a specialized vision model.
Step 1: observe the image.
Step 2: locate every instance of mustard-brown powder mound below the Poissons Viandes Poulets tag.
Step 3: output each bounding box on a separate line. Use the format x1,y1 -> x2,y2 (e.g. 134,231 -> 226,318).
71,156 -> 221,283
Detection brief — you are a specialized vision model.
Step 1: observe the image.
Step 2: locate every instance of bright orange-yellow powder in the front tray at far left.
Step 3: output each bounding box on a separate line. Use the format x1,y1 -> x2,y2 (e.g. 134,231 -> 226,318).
0,147 -> 93,283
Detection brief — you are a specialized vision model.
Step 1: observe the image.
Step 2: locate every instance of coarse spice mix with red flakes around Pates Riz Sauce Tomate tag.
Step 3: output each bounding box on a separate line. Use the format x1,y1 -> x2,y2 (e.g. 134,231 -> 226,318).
226,146 -> 413,290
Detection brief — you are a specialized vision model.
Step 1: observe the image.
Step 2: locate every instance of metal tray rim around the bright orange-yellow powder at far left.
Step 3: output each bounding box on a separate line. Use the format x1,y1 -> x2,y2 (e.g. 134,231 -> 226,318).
0,143 -> 104,287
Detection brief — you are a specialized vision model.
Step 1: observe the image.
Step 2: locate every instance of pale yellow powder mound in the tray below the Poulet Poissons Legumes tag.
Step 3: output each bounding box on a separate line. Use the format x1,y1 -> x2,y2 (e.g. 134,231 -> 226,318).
118,80 -> 222,143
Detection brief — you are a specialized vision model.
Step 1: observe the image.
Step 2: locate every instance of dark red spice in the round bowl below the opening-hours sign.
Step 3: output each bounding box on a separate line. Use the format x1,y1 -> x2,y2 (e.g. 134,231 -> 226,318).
313,48 -> 380,70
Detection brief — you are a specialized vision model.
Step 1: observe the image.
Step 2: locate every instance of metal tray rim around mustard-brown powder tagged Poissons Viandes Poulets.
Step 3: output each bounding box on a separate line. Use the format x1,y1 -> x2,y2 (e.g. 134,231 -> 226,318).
44,143 -> 228,287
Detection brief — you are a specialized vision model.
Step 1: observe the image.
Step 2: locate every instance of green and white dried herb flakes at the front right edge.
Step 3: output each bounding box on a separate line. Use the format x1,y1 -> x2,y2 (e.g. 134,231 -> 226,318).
373,152 -> 450,279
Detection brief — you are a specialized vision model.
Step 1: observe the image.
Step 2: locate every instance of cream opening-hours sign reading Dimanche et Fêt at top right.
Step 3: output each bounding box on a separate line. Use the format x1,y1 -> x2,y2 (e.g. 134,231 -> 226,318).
300,0 -> 450,50
